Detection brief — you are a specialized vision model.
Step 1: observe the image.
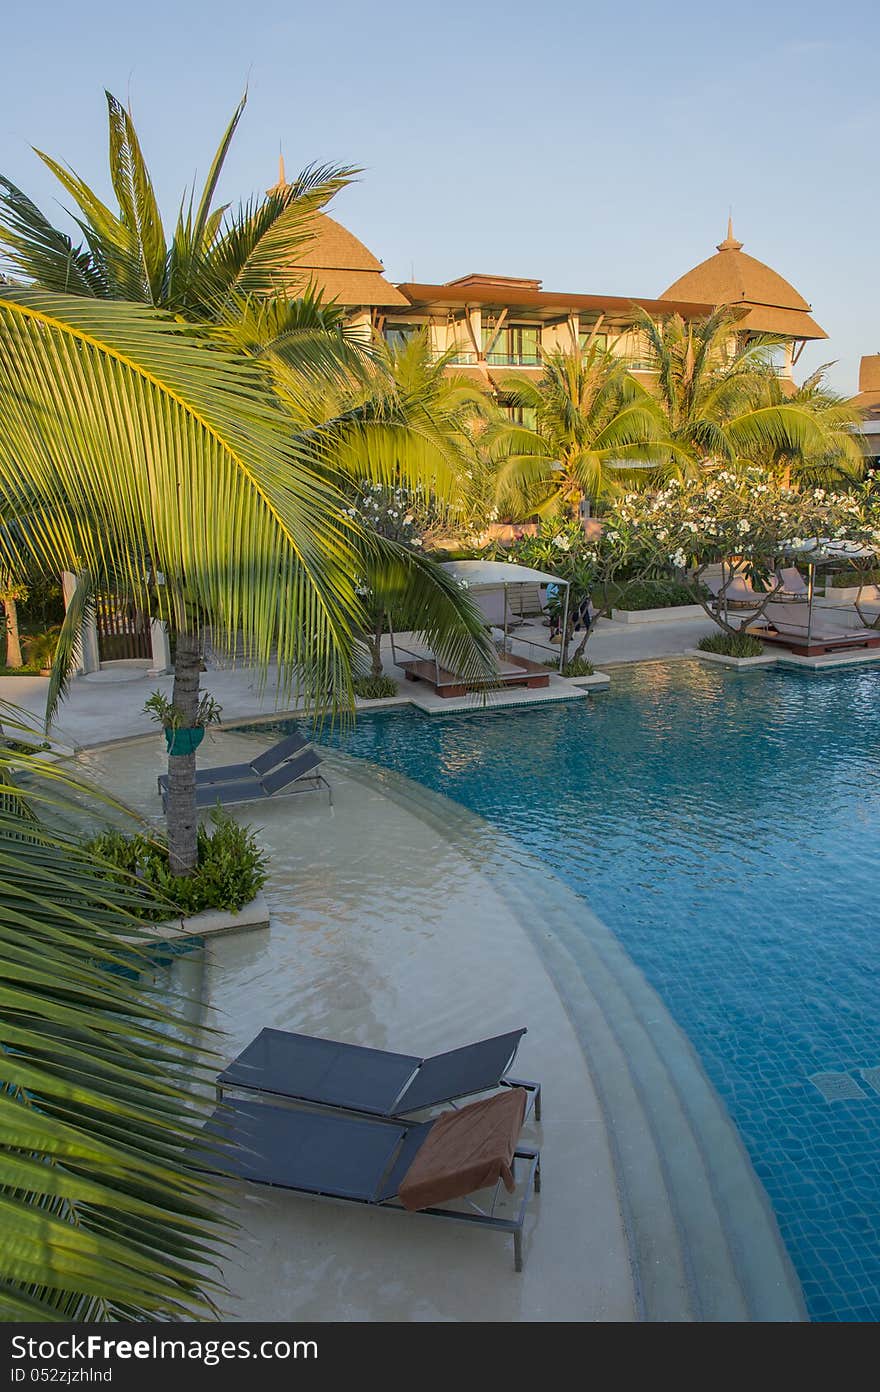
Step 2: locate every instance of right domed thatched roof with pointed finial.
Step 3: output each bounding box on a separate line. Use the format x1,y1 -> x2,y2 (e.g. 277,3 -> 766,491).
660,221 -> 828,338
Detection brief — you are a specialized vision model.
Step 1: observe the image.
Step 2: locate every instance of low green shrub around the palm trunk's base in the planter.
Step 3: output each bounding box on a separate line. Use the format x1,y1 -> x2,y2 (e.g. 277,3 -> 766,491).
86,807 -> 266,920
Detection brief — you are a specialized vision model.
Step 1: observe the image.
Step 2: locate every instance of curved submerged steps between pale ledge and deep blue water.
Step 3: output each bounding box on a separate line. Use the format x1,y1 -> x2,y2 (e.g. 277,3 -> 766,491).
347,766 -> 805,1321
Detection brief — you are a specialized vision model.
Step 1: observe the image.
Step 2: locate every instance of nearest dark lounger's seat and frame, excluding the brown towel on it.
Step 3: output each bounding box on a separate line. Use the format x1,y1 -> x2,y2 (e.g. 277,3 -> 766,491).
189,1100 -> 540,1271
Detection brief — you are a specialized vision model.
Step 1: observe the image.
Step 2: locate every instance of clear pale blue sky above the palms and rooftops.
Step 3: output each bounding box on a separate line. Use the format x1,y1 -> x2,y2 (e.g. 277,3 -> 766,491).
0,0 -> 880,391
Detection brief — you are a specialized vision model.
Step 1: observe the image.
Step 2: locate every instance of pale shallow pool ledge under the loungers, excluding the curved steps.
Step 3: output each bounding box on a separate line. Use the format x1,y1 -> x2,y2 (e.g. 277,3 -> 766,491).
73,735 -> 636,1321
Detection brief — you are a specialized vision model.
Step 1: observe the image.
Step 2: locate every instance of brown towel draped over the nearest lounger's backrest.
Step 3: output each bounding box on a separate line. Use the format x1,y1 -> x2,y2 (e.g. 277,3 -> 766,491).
400,1087 -> 526,1208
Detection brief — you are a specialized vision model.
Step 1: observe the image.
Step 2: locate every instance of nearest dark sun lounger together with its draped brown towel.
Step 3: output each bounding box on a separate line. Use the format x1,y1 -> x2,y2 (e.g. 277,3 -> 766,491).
191,1089 -> 540,1271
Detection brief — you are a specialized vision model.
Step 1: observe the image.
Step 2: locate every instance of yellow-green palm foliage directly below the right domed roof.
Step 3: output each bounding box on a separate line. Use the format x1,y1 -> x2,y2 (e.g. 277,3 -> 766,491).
634,306 -> 857,473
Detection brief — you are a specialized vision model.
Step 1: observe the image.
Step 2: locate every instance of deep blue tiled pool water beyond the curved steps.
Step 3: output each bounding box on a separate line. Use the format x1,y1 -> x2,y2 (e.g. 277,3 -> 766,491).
254,663 -> 880,1320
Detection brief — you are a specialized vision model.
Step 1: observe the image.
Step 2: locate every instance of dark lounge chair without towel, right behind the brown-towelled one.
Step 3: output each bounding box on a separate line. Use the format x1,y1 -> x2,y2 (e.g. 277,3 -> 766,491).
217,1029 -> 540,1121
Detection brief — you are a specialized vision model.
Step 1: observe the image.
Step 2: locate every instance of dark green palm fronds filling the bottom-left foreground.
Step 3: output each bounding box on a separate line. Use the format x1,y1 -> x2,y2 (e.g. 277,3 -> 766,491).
0,709 -> 224,1322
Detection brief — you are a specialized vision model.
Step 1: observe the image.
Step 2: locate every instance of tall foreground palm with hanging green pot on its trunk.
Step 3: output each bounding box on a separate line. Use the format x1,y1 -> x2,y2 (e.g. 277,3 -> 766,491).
0,93 -> 490,874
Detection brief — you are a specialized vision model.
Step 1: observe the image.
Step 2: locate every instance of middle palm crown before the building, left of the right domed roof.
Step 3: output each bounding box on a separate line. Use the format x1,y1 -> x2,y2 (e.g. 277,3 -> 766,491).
489,344 -> 660,516
